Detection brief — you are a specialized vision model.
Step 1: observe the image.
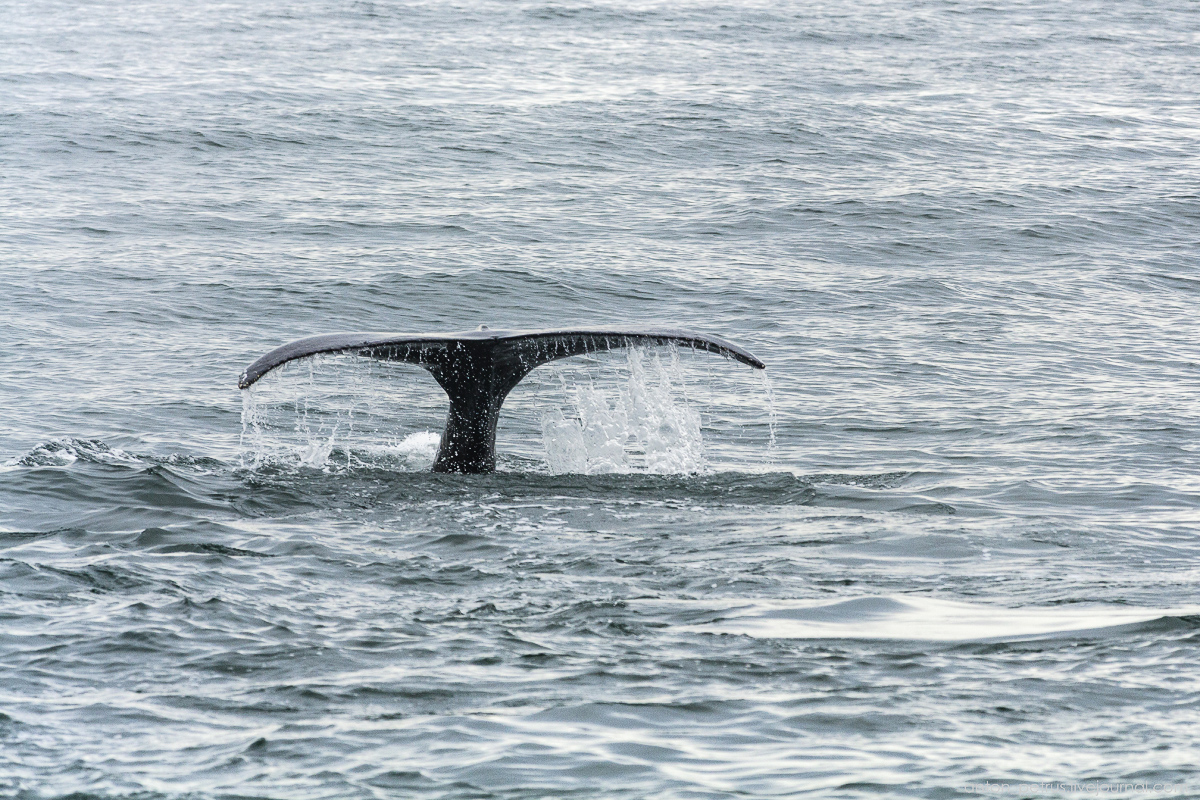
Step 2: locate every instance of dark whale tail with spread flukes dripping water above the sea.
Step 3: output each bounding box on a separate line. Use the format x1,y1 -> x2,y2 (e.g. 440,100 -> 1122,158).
238,325 -> 767,473
